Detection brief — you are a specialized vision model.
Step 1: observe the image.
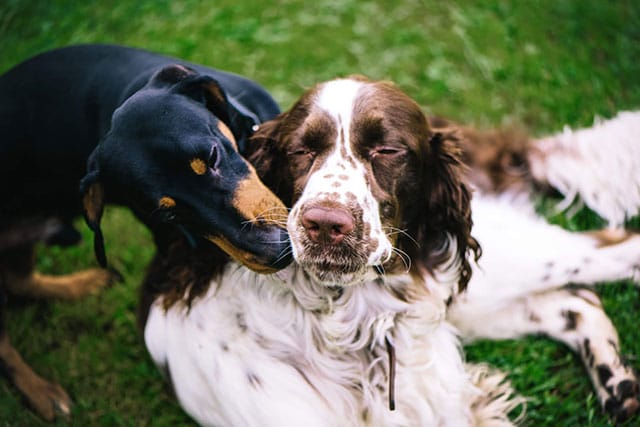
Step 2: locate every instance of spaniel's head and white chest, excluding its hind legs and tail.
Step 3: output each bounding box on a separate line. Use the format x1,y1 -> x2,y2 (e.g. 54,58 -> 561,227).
145,77 -> 521,427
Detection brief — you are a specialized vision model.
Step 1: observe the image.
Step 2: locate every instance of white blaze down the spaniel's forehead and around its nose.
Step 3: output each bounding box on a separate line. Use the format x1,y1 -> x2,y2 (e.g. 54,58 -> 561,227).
290,80 -> 392,265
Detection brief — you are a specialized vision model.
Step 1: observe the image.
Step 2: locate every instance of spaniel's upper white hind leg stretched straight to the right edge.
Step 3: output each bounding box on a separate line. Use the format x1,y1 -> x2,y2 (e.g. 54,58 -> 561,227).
468,197 -> 640,302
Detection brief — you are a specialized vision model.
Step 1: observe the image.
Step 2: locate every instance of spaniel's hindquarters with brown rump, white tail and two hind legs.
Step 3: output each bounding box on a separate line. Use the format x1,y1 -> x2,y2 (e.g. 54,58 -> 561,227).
444,112 -> 640,421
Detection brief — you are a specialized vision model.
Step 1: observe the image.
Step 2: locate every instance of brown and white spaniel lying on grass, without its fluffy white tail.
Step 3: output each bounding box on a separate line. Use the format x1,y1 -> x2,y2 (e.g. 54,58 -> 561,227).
145,77 -> 640,426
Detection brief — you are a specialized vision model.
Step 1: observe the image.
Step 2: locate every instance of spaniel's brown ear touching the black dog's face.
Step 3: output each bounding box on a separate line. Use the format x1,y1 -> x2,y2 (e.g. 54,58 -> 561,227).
244,113 -> 293,207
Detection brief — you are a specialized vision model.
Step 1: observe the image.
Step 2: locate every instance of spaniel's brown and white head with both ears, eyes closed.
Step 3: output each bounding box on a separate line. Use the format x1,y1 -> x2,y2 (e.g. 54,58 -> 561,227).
248,77 -> 479,289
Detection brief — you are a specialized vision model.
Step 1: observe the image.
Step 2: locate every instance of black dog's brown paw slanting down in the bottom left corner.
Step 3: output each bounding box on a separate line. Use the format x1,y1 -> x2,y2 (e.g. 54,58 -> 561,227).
0,334 -> 71,421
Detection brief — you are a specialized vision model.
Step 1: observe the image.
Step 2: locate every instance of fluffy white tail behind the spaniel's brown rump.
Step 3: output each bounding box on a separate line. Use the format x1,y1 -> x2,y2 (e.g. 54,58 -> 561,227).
529,111 -> 640,227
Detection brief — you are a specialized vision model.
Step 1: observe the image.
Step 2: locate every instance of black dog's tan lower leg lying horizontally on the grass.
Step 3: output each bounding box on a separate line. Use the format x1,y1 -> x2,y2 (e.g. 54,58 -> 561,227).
6,268 -> 116,299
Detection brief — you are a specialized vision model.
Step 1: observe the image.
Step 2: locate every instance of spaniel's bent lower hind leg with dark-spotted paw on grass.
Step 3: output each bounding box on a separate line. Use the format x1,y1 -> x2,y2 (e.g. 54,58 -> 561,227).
448,289 -> 640,420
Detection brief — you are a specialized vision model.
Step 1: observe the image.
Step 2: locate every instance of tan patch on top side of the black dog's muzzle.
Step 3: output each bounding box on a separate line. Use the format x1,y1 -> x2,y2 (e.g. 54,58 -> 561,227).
232,167 -> 288,225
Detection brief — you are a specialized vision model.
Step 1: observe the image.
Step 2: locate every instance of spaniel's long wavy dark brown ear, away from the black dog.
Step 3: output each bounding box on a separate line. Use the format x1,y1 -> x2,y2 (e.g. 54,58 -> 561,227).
420,127 -> 481,291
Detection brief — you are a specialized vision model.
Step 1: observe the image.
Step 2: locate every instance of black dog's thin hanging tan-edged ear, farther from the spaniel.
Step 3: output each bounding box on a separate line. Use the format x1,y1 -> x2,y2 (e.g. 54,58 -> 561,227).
80,149 -> 107,268
